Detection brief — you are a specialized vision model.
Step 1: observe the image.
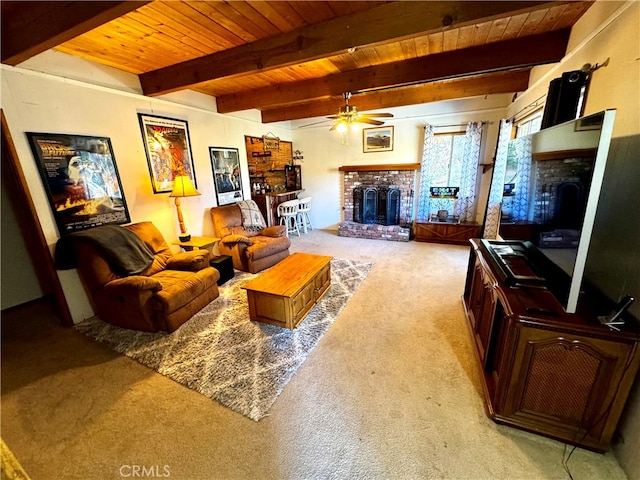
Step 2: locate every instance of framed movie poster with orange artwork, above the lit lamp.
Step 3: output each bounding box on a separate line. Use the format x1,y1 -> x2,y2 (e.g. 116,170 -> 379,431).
138,113 -> 198,193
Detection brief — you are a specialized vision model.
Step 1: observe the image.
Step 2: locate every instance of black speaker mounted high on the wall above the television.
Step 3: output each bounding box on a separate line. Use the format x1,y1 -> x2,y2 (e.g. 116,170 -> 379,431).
541,70 -> 587,128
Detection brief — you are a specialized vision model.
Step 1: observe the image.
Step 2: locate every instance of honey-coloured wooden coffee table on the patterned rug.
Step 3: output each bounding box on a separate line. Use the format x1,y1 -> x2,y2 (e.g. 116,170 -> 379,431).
242,253 -> 333,330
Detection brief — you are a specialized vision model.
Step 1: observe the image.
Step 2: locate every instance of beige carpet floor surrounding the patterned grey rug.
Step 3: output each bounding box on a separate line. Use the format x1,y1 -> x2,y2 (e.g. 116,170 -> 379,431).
2,230 -> 625,480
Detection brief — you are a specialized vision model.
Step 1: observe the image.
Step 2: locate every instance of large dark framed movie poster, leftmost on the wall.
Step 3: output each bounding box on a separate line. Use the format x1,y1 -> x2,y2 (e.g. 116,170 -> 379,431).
27,132 -> 131,235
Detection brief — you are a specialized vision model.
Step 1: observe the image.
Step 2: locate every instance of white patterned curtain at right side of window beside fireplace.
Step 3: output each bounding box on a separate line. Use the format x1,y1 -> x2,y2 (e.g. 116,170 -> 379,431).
456,122 -> 482,223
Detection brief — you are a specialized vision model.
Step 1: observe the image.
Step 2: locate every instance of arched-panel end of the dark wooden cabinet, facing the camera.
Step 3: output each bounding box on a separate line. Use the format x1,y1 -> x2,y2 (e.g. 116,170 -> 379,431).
501,326 -> 634,451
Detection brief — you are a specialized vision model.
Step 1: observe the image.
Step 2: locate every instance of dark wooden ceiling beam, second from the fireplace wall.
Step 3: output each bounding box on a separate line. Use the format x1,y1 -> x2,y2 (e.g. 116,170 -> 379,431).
216,29 -> 570,113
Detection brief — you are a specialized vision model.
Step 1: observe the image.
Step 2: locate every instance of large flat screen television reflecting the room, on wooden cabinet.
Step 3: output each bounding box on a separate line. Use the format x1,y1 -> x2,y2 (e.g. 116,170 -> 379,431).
500,110 -> 616,313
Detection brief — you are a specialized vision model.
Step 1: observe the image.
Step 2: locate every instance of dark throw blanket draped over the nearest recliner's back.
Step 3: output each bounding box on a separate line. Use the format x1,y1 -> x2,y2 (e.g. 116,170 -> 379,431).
55,225 -> 154,277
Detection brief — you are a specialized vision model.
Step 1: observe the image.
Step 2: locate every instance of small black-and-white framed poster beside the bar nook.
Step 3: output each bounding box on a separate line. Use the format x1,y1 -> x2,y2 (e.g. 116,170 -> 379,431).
209,147 -> 244,205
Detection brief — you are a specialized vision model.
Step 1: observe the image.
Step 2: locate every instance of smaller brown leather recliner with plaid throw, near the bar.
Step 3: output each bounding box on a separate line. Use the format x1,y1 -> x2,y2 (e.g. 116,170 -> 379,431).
211,204 -> 291,273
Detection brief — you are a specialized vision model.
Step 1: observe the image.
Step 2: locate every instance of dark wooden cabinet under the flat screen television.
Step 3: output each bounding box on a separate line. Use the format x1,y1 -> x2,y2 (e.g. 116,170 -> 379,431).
463,240 -> 640,452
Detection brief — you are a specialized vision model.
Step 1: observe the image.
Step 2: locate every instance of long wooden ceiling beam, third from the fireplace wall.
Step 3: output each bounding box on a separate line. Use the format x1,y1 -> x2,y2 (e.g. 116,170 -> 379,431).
139,1 -> 566,95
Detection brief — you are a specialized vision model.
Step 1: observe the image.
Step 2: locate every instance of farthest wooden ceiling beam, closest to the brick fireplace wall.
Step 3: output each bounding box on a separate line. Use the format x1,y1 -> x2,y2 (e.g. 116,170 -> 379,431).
262,68 -> 530,123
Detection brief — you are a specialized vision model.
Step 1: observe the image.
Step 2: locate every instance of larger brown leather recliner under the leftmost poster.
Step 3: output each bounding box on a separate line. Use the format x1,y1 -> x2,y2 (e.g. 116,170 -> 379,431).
56,222 -> 220,332
